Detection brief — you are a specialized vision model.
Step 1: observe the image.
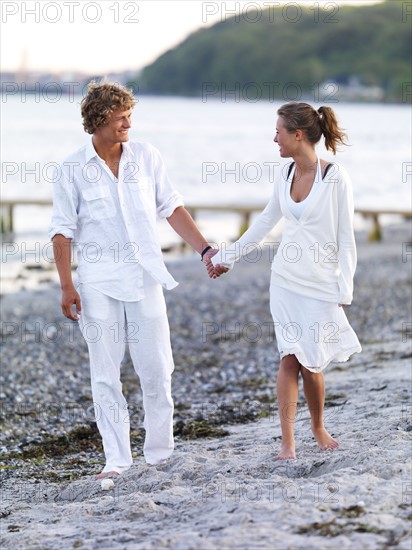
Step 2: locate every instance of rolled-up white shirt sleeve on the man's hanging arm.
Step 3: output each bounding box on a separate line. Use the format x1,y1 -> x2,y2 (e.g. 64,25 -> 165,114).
49,170 -> 78,239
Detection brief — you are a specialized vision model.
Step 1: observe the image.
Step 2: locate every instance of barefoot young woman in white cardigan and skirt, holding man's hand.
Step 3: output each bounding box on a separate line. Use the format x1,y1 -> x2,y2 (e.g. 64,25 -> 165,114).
209,103 -> 361,459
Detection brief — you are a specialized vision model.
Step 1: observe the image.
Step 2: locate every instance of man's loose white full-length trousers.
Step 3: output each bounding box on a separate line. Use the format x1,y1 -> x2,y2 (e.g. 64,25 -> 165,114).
79,274 -> 174,473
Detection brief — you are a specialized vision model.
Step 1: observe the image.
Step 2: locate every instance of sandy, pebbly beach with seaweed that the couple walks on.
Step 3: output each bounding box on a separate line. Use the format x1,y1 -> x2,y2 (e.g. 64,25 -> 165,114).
0,223 -> 412,550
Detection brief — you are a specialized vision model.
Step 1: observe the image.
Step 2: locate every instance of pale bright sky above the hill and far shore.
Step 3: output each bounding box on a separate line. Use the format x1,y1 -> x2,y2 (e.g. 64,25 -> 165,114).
0,0 -> 379,74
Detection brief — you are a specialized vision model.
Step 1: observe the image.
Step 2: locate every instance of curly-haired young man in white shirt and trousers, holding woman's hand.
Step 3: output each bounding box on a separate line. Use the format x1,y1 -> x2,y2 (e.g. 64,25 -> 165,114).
50,83 -> 217,479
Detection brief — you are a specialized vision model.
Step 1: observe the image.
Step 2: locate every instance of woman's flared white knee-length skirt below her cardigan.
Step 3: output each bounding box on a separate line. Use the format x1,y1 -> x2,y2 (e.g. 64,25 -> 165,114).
270,283 -> 362,372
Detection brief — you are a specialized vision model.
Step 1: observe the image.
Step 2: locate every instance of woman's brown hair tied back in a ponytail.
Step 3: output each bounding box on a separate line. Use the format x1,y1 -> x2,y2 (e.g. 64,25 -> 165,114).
277,103 -> 347,155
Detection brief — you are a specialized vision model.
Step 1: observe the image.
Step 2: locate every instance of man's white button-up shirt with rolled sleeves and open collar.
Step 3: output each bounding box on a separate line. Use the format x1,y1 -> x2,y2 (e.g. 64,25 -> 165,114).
49,139 -> 183,301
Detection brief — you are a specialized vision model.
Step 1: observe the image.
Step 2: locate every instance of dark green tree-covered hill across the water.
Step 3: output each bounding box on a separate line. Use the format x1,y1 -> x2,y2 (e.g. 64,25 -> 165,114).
137,0 -> 412,102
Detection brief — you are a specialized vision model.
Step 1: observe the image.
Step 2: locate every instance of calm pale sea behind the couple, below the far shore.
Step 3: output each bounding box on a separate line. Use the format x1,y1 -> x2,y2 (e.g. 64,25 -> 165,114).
1,95 -> 412,292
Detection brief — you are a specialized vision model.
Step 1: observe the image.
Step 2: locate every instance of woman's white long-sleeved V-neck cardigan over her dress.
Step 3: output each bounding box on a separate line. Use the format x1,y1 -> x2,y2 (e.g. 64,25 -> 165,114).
212,163 -> 356,304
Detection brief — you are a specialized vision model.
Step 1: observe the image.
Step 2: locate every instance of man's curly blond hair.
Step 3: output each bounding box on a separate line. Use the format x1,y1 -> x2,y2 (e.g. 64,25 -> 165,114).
81,81 -> 136,134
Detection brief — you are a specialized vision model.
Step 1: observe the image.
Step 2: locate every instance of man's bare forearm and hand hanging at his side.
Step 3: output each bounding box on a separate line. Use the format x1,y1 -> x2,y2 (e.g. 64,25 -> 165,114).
53,233 -> 81,321
